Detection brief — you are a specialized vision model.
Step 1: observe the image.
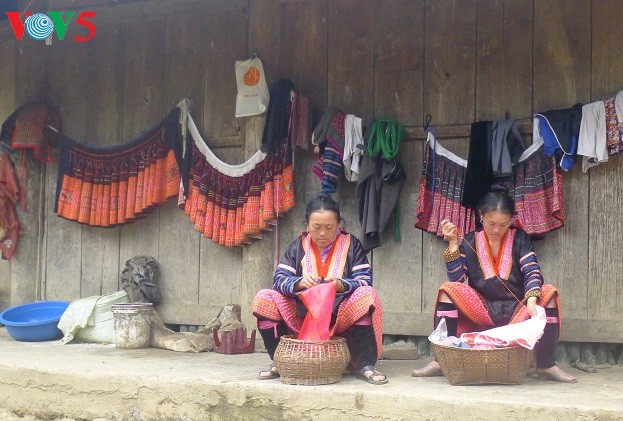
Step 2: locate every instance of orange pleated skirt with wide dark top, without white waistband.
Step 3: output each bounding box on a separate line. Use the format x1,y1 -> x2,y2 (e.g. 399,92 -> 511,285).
54,109 -> 183,227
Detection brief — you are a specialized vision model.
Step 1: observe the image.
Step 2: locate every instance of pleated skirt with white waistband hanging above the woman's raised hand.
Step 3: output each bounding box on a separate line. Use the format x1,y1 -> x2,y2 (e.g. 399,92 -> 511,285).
415,133 -> 475,237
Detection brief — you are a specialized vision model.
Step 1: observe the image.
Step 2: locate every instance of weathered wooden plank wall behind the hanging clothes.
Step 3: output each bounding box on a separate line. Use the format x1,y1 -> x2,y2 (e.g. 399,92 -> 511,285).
0,0 -> 623,342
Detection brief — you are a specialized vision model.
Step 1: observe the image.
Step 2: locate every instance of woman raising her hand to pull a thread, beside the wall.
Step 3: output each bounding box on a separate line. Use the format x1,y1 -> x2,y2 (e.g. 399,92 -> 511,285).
412,191 -> 577,383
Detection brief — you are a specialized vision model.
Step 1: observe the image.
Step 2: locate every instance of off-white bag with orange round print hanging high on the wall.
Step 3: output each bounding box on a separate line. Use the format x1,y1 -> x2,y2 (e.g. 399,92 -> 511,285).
236,56 -> 270,117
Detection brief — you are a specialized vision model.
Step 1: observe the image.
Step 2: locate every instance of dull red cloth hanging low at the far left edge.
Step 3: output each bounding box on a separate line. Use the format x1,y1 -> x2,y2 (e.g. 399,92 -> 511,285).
0,151 -> 22,260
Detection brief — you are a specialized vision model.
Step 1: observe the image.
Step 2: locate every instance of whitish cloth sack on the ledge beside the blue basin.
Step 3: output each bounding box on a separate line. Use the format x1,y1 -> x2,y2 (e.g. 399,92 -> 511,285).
58,291 -> 130,344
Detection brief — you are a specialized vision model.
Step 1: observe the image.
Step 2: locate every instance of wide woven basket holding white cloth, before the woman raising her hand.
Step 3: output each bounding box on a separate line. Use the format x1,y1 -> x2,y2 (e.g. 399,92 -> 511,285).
432,343 -> 532,385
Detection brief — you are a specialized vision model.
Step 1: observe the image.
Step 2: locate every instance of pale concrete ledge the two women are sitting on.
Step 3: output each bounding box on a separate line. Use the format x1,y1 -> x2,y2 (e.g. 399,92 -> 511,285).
0,329 -> 623,421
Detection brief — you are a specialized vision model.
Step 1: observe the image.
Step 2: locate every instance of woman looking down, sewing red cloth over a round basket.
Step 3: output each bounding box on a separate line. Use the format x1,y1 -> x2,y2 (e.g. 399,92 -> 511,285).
253,194 -> 387,384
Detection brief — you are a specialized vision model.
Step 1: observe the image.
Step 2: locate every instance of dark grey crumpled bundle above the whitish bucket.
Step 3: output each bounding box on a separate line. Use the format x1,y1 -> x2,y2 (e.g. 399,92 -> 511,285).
121,256 -> 161,304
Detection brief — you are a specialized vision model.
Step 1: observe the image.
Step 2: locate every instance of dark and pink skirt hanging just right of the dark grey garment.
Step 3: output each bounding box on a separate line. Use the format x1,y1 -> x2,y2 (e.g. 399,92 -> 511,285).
509,139 -> 565,238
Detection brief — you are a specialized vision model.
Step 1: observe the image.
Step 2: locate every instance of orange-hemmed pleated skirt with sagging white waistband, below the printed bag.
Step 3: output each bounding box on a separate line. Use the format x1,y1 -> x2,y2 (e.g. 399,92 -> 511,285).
180,115 -> 294,247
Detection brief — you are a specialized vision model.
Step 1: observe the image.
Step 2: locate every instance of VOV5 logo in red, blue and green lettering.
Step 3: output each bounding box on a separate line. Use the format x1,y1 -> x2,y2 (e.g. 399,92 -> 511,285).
5,11 -> 97,42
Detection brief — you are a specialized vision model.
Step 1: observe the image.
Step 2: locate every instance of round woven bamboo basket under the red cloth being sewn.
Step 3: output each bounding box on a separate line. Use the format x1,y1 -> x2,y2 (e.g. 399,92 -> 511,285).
274,335 -> 350,386
